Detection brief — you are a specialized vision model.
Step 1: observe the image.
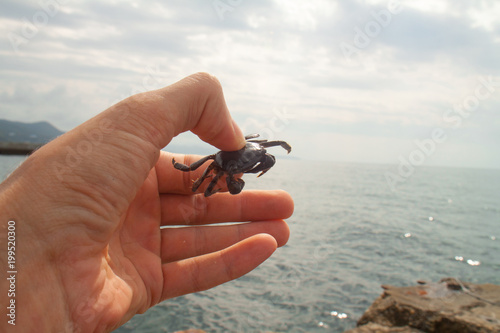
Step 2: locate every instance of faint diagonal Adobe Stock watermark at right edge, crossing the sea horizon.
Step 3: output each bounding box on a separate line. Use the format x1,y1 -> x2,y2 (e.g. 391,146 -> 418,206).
385,76 -> 500,191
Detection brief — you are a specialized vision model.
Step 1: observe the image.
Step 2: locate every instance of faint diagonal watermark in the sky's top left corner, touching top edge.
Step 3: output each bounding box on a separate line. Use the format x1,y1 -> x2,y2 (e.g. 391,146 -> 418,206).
7,0 -> 68,53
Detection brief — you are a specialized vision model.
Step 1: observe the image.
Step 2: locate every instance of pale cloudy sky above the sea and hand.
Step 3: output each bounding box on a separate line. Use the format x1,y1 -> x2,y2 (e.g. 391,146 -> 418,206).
0,0 -> 500,169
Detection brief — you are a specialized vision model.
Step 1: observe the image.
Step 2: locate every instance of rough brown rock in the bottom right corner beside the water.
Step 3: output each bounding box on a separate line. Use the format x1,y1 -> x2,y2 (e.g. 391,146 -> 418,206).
348,278 -> 500,333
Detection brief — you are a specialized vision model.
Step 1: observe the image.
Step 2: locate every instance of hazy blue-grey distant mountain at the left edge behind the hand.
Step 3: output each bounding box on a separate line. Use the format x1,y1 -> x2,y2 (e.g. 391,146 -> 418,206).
0,119 -> 64,143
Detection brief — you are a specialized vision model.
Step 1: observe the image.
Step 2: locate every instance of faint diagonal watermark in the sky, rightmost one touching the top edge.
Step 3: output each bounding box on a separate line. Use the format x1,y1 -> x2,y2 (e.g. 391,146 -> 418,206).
339,0 -> 403,64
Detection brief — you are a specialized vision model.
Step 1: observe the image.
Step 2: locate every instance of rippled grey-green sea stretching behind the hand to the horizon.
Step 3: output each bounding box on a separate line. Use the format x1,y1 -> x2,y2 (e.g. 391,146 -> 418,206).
0,156 -> 500,333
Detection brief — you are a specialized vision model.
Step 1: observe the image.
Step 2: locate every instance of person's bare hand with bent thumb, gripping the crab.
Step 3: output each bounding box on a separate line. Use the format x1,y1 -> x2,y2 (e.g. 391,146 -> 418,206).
0,73 -> 293,332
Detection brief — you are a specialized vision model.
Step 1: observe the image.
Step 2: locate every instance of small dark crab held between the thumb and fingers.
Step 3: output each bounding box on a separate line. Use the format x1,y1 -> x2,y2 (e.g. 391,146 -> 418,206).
172,134 -> 292,197
